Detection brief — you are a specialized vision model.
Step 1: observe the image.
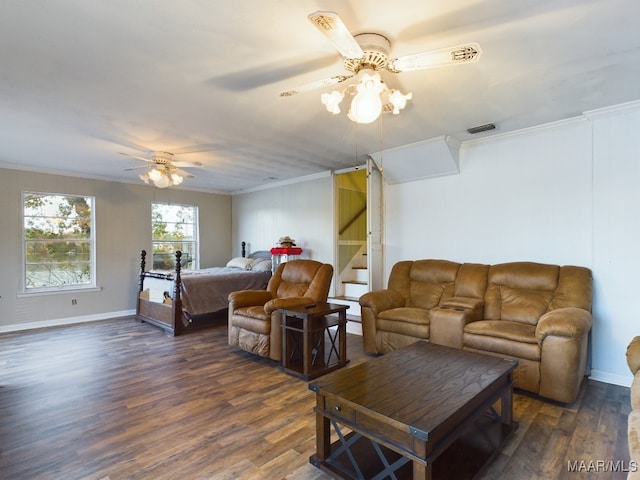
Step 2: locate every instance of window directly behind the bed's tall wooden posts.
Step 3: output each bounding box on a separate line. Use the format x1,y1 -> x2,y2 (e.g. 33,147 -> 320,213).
151,203 -> 200,270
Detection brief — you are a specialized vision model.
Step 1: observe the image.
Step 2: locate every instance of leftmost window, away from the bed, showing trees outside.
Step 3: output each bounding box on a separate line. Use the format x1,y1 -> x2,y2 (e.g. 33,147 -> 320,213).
22,192 -> 96,292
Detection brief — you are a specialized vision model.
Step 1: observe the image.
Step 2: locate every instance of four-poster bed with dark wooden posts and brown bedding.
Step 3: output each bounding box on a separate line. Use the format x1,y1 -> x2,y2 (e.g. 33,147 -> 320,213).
136,242 -> 272,335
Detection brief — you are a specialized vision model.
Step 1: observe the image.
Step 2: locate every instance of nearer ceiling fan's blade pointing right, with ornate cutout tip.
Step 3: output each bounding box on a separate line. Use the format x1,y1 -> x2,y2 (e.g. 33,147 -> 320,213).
387,43 -> 482,73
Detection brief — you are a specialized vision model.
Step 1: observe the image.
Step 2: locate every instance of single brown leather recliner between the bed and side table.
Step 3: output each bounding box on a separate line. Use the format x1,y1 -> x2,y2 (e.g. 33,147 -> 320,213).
229,260 -> 333,360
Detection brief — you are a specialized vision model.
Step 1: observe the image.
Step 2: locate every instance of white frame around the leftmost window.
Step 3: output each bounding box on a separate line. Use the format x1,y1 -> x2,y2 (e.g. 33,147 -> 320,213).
20,190 -> 98,295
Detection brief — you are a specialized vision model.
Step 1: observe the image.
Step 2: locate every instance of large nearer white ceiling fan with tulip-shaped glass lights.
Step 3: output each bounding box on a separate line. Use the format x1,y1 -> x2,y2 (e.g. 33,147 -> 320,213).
280,11 -> 482,123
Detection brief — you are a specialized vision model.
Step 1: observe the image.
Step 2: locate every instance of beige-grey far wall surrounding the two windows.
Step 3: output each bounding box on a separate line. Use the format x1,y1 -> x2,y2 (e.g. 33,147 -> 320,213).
0,169 -> 230,332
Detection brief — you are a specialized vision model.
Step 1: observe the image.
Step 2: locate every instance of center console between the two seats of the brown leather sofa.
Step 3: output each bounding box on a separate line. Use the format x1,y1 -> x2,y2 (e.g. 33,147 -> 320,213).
429,297 -> 484,349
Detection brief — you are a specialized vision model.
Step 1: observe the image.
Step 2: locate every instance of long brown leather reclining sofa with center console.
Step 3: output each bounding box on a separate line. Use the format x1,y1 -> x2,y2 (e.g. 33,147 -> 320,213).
360,260 -> 593,403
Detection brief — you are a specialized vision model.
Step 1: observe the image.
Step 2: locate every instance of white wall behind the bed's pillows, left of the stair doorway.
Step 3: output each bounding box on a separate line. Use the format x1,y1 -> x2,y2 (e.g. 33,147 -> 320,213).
232,173 -> 334,264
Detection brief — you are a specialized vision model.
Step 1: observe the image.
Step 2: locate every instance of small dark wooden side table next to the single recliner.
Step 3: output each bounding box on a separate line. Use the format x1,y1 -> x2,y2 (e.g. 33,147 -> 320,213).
280,303 -> 349,380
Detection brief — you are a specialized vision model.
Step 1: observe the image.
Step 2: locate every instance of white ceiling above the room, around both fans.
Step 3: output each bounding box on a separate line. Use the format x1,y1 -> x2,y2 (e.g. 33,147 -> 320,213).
0,0 -> 640,192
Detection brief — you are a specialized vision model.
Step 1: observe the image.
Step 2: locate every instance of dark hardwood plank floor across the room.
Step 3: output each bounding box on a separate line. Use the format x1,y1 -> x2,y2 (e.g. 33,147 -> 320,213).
0,318 -> 630,480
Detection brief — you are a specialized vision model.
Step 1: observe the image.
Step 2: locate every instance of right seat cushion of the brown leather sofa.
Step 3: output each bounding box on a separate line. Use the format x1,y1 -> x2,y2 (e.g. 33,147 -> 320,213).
463,320 -> 540,361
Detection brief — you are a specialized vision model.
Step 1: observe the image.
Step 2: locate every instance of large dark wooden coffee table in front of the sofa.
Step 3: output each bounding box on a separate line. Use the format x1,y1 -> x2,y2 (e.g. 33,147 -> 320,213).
309,342 -> 517,479
